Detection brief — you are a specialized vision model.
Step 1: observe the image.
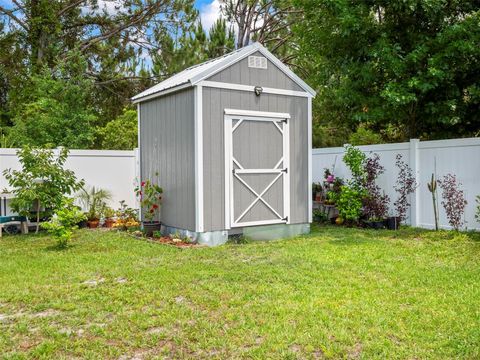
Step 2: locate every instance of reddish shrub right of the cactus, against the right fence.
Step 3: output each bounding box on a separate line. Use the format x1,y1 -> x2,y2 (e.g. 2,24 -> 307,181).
438,174 -> 467,230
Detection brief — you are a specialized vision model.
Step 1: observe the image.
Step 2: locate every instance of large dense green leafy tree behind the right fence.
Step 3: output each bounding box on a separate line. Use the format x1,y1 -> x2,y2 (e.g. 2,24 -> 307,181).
293,0 -> 480,141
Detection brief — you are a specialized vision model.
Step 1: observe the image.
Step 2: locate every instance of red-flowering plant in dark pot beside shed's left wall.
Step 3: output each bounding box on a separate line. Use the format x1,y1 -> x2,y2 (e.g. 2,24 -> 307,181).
135,175 -> 163,236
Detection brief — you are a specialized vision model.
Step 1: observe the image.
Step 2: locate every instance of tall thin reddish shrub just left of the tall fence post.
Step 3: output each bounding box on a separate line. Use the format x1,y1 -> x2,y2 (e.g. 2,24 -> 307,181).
393,154 -> 417,221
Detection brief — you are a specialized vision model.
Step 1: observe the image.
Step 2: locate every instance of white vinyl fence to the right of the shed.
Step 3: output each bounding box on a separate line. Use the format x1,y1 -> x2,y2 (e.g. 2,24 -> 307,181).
312,138 -> 480,230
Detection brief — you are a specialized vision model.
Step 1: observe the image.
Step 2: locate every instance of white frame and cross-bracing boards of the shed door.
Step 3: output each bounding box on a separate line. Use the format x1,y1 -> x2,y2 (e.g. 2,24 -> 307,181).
224,109 -> 290,229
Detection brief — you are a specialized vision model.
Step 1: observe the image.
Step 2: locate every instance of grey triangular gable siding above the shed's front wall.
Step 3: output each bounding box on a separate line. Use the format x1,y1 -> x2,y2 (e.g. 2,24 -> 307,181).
207,52 -> 304,91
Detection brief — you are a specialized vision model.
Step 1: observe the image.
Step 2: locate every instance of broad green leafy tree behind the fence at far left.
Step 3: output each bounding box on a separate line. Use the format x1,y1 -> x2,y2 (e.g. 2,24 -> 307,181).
9,65 -> 96,149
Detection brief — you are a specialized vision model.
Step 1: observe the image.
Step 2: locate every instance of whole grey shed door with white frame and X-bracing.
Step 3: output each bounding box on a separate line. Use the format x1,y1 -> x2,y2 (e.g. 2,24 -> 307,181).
225,110 -> 290,228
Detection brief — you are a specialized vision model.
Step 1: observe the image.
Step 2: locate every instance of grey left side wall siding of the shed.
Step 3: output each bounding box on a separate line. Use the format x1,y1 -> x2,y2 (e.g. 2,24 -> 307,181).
140,89 -> 195,231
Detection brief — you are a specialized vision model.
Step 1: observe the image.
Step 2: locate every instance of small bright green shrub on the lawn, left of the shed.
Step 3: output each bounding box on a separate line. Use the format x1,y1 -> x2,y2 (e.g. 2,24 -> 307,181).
42,198 -> 86,248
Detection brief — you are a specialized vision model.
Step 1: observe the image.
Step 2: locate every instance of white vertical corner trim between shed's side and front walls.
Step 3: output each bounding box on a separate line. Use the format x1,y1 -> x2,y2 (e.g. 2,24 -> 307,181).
194,85 -> 204,232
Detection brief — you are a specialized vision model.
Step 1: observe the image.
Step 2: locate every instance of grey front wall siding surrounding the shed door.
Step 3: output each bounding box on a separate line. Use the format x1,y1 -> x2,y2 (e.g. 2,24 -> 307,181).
203,88 -> 308,231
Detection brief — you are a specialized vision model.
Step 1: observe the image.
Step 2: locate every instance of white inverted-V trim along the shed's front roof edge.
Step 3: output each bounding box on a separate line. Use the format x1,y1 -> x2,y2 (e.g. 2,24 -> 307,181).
190,43 -> 317,96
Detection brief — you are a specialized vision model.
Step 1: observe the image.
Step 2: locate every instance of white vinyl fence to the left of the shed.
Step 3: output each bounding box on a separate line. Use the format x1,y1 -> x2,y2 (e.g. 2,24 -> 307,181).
0,149 -> 138,209
